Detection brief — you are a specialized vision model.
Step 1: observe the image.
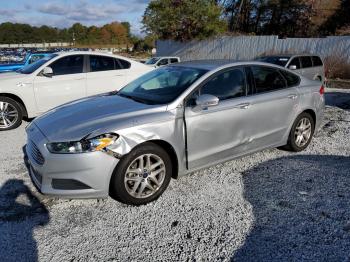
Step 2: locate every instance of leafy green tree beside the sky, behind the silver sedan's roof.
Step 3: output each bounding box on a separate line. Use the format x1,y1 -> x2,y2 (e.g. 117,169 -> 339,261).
142,0 -> 226,41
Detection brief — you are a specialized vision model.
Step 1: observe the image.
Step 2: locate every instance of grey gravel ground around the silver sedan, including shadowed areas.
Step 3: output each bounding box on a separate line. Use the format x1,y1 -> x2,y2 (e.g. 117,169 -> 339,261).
0,90 -> 350,261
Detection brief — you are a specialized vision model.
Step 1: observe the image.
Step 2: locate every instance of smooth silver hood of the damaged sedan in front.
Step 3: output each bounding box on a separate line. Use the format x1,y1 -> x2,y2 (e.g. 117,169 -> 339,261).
33,94 -> 164,142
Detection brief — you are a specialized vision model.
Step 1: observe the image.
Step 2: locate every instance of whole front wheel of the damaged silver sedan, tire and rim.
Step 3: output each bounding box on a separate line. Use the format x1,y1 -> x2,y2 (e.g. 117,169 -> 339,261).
110,142 -> 172,205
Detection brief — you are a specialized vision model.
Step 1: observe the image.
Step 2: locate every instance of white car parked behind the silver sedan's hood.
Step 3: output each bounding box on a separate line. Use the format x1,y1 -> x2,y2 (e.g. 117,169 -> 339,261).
0,52 -> 152,131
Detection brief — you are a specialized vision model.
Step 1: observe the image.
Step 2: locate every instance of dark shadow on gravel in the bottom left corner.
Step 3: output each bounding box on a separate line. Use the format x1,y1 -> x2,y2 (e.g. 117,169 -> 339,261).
0,179 -> 50,262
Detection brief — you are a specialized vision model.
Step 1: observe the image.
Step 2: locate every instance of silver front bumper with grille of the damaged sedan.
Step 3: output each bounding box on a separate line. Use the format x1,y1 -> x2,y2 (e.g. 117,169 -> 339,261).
25,124 -> 119,198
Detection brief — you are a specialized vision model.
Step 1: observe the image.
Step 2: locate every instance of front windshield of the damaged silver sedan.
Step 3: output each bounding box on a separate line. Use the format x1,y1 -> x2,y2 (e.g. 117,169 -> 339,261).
118,66 -> 207,104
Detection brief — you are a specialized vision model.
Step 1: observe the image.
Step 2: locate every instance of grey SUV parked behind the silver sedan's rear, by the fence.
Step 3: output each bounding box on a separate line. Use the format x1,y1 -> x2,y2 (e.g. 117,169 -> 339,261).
257,55 -> 325,82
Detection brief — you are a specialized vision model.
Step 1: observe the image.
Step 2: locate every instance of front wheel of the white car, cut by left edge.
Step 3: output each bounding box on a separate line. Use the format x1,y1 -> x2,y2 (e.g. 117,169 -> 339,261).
0,96 -> 23,131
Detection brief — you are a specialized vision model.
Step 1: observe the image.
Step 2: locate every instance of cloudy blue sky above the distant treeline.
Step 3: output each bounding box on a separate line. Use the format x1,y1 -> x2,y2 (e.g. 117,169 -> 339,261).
0,0 -> 149,35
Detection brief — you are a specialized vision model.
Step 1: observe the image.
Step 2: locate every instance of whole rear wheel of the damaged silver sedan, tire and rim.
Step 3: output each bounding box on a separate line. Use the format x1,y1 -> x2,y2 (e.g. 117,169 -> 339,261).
282,112 -> 315,152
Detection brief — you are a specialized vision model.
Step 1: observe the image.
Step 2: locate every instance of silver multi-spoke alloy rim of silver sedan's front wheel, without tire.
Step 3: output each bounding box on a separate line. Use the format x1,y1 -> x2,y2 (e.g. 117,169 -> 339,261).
124,154 -> 166,198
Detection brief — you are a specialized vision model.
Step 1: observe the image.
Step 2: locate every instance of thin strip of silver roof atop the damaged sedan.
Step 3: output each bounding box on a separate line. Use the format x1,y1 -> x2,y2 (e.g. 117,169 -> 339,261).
169,59 -> 285,71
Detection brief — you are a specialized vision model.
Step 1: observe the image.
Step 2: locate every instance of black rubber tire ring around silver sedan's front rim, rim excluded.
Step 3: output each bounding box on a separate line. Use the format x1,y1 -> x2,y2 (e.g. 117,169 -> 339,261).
110,142 -> 172,205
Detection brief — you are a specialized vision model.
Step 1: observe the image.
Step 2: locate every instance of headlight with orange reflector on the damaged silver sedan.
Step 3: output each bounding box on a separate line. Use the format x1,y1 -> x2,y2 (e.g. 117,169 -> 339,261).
46,134 -> 118,154
